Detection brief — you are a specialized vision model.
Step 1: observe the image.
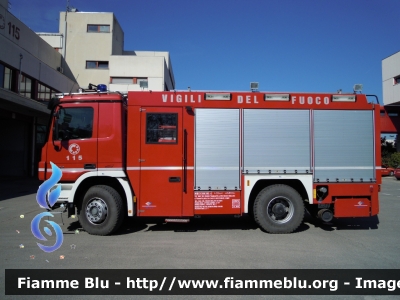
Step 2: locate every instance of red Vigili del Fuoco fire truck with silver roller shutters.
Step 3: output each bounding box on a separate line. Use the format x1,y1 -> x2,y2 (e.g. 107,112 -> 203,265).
39,85 -> 381,235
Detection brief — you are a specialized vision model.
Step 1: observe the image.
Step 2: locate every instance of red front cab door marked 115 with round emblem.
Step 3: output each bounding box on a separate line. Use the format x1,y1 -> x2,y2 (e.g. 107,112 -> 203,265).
46,103 -> 98,182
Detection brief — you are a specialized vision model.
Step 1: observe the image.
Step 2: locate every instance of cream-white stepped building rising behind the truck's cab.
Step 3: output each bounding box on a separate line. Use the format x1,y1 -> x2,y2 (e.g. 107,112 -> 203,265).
38,9 -> 175,92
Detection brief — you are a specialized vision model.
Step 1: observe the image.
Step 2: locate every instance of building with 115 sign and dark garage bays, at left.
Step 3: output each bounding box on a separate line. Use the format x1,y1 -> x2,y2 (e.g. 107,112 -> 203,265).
0,0 -> 78,176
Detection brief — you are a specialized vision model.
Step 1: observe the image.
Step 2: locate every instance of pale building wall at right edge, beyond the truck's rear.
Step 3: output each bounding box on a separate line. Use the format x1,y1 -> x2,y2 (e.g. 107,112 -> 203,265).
382,52 -> 400,105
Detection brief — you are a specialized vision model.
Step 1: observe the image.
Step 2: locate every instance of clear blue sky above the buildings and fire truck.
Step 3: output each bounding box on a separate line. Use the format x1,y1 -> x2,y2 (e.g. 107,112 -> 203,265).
10,0 -> 400,103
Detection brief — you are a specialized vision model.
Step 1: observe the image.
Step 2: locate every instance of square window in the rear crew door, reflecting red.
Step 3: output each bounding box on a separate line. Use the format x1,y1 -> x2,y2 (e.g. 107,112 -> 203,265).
146,113 -> 178,144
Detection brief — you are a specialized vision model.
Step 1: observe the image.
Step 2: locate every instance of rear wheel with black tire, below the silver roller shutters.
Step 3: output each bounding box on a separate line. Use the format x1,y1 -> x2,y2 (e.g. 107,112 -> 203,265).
254,184 -> 304,233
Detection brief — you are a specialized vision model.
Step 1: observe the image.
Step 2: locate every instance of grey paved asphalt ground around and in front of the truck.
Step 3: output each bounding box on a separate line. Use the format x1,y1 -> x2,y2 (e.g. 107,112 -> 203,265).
0,177 -> 400,299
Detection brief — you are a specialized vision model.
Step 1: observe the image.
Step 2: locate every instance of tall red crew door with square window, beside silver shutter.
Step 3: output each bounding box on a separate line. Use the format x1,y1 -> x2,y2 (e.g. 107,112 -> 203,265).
138,107 -> 184,216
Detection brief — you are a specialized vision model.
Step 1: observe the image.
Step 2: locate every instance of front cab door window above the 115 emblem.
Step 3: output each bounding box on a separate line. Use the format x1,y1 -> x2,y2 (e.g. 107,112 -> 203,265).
57,107 -> 93,140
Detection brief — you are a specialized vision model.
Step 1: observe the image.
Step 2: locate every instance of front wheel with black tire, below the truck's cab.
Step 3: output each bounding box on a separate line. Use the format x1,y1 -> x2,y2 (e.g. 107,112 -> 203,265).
78,185 -> 124,235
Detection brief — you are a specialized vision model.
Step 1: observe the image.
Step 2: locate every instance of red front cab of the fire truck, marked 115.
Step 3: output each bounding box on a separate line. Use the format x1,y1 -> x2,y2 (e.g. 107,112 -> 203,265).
39,92 -> 128,233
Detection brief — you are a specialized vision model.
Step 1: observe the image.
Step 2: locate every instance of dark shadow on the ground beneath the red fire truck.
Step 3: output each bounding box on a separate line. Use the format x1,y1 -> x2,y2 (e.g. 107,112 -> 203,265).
68,213 -> 379,235
